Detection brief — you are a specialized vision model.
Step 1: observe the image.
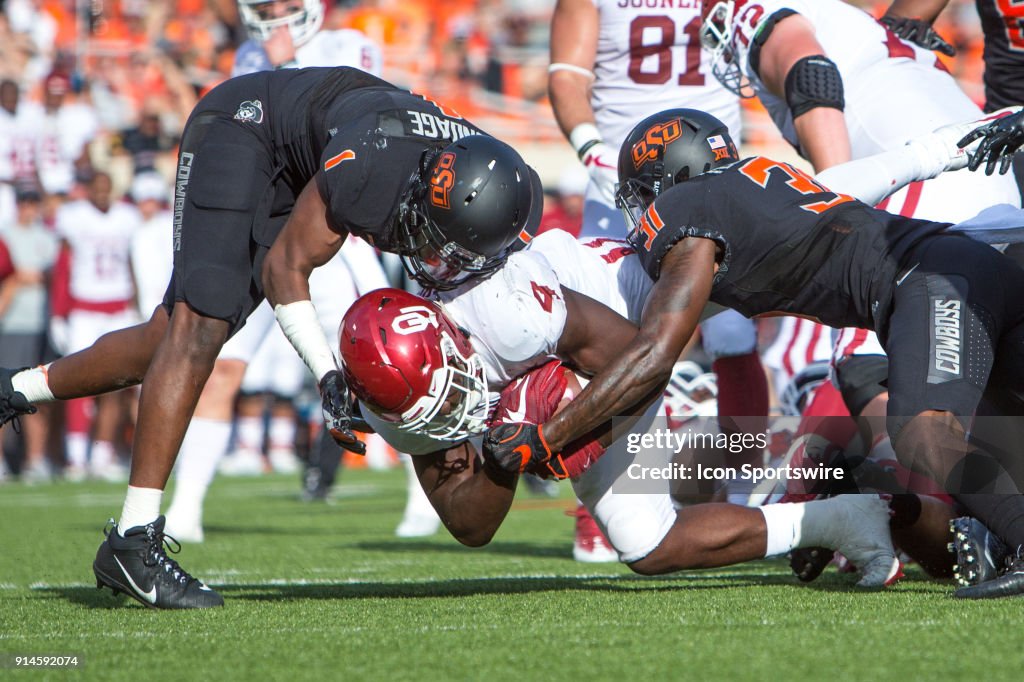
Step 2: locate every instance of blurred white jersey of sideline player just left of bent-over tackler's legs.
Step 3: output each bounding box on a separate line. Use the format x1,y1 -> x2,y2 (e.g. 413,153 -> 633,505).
56,200 -> 141,303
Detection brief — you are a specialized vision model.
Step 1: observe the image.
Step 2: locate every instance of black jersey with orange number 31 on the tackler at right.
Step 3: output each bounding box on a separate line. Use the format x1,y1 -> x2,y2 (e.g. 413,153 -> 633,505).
630,157 -> 947,329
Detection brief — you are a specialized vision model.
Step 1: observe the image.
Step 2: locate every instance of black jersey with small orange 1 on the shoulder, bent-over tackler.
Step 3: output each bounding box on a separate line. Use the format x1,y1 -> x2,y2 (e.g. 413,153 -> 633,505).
242,67 -> 482,250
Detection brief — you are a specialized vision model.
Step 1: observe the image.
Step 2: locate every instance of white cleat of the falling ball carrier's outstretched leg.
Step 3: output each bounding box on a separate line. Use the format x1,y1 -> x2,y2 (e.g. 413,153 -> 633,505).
815,495 -> 902,587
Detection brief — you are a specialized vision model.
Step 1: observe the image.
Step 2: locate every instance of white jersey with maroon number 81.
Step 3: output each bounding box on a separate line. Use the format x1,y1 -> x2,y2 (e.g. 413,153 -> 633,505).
591,0 -> 740,148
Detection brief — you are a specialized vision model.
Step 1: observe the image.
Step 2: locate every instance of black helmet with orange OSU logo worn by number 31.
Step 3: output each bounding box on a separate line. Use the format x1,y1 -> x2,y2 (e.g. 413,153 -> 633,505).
615,109 -> 739,228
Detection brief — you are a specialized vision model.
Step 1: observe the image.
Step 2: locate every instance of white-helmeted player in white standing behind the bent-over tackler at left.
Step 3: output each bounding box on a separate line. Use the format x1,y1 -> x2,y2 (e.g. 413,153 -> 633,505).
164,0 -> 386,543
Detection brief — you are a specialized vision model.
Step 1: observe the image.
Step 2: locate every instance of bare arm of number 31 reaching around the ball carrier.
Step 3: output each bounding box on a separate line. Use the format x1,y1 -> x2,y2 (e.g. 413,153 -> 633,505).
520,239 -> 716,455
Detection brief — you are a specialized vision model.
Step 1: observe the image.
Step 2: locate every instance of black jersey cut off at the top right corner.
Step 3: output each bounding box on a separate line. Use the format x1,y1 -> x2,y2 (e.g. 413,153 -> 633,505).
975,0 -> 1024,112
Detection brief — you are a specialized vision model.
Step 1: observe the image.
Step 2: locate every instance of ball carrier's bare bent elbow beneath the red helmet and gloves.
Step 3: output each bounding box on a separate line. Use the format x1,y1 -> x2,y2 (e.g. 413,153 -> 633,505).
413,442 -> 519,547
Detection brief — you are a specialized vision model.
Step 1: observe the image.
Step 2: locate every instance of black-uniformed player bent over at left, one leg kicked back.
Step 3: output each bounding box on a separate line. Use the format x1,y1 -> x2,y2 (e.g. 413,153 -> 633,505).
0,68 -> 542,608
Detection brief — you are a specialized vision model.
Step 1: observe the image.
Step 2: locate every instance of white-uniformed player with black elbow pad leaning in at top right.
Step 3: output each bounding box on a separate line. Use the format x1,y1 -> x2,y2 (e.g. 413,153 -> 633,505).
701,0 -> 1020,516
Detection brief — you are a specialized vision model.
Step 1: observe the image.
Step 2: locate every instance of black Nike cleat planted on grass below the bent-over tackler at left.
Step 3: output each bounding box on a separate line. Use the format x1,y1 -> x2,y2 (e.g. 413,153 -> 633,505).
92,516 -> 224,608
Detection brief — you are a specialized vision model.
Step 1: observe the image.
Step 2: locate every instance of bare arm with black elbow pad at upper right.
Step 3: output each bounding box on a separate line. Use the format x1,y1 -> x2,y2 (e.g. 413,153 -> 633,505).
758,14 -> 851,171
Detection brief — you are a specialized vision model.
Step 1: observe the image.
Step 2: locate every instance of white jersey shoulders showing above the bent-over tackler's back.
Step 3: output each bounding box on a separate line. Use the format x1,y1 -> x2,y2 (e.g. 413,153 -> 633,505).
231,29 -> 384,78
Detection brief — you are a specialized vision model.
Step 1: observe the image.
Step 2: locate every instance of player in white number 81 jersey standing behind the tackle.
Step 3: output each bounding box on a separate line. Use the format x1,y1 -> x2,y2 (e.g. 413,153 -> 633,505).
548,0 -> 769,509
